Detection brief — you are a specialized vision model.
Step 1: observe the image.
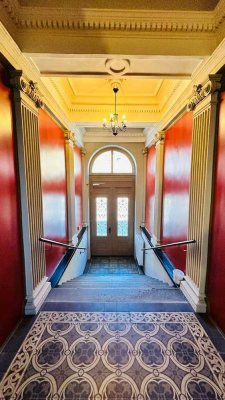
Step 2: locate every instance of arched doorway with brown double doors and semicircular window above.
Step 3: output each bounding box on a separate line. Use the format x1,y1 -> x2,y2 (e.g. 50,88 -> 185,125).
89,146 -> 136,256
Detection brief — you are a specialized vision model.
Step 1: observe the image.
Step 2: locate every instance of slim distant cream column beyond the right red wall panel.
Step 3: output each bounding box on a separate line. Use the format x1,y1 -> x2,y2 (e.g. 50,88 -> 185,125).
153,131 -> 165,244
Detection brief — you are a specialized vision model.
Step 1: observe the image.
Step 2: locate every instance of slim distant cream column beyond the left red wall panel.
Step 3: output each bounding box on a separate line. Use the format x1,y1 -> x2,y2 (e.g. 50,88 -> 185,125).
65,130 -> 76,243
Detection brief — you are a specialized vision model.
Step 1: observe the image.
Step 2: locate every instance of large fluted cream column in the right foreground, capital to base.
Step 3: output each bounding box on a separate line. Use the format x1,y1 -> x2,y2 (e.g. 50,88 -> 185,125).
181,75 -> 222,312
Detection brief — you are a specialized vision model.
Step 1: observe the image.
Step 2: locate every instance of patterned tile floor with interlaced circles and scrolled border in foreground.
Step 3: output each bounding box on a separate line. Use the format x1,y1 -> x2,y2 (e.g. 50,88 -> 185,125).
0,312 -> 225,400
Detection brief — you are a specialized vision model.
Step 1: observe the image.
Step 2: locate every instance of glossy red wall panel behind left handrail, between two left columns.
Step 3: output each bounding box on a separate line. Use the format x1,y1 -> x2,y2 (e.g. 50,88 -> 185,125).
39,110 -> 67,276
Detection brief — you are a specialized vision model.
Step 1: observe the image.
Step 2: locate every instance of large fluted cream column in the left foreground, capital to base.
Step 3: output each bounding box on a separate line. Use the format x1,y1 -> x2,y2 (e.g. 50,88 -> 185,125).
11,71 -> 51,314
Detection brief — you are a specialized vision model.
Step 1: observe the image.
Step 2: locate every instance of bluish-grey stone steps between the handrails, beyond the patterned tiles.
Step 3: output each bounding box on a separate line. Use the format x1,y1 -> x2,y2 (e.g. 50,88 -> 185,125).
47,273 -> 188,308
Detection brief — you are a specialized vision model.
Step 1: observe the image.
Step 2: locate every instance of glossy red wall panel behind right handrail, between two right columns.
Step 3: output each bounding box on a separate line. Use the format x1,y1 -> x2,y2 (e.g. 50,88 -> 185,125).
162,113 -> 193,271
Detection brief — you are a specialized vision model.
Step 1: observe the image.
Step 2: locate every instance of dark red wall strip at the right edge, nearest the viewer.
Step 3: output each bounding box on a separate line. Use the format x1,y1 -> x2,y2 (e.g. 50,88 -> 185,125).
208,93 -> 225,332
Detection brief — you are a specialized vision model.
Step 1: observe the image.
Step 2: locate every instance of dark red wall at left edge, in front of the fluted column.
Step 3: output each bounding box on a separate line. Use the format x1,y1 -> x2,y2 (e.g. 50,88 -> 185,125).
0,64 -> 24,344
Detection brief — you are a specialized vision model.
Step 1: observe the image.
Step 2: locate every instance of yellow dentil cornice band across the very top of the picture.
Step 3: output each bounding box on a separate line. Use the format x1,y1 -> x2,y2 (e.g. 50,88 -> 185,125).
0,0 -> 221,34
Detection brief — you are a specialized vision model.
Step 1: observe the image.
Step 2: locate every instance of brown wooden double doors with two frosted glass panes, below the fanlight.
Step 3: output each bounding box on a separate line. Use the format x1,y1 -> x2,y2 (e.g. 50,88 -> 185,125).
90,176 -> 134,256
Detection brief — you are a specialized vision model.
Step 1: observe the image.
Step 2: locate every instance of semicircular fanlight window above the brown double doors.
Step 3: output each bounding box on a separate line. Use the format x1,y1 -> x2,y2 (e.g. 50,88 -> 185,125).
91,150 -> 133,174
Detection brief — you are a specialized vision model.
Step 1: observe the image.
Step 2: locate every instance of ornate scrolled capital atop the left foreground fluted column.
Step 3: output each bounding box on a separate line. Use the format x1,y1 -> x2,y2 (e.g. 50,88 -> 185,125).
10,70 -> 44,108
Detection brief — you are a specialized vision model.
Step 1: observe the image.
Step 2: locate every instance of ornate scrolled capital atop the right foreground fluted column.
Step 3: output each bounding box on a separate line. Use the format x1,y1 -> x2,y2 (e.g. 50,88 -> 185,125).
187,75 -> 222,111
